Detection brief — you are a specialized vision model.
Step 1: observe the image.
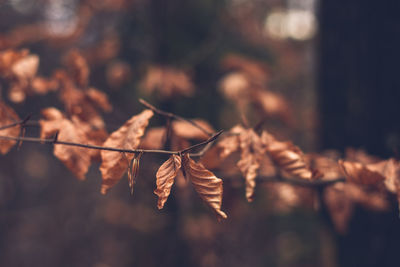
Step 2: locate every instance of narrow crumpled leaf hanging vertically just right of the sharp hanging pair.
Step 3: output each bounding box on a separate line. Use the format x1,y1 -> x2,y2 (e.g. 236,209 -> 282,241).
237,129 -> 264,202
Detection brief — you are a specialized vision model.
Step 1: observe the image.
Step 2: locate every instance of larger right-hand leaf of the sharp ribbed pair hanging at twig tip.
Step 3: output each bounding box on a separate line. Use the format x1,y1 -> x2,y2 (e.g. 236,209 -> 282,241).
183,154 -> 227,219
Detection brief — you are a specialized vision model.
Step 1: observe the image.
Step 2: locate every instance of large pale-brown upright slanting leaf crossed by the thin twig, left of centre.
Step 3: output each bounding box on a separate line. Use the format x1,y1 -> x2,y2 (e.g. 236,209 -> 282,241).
100,109 -> 153,194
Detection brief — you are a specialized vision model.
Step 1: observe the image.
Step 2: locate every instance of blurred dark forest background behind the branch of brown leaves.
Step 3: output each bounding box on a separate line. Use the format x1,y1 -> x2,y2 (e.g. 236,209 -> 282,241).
0,0 -> 400,267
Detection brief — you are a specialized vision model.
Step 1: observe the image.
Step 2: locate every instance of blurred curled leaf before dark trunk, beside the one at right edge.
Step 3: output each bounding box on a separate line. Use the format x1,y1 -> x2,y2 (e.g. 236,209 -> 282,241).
339,160 -> 385,185
